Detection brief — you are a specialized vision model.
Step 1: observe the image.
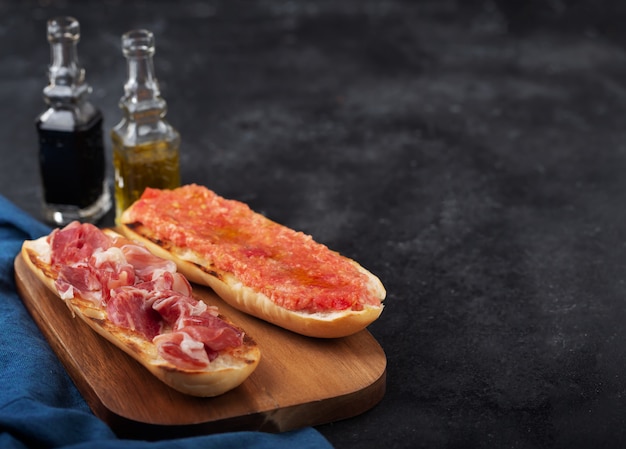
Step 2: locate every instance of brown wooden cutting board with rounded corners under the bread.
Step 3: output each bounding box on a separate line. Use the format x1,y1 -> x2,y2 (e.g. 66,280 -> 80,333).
15,256 -> 387,440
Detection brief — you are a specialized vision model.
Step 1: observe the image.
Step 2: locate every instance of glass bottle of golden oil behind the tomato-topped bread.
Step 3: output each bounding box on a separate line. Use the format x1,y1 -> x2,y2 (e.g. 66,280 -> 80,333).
111,30 -> 180,220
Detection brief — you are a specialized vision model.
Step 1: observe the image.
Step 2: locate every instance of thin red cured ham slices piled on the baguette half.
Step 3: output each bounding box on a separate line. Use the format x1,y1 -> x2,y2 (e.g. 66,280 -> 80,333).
49,222 -> 243,368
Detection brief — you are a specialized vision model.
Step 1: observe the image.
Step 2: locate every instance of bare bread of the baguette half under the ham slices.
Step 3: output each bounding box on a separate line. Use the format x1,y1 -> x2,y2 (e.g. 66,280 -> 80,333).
21,230 -> 261,397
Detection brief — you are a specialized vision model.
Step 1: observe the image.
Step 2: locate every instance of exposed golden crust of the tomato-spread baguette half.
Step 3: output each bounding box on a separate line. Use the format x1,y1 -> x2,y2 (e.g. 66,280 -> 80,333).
119,219 -> 386,338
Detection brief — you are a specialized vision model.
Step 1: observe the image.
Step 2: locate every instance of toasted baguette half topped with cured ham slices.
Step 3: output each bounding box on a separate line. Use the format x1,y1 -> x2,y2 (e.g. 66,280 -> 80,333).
21,222 -> 260,397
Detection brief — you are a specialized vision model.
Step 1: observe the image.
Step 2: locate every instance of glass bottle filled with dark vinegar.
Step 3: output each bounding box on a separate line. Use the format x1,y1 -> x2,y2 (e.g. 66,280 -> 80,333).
36,17 -> 111,226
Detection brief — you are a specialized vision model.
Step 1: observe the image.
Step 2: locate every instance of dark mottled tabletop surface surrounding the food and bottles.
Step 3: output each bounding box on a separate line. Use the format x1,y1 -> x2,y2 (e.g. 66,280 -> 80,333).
0,0 -> 626,449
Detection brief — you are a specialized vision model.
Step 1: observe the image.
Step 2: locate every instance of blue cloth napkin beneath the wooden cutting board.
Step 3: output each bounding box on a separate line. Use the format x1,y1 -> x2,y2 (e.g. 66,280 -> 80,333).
0,195 -> 332,449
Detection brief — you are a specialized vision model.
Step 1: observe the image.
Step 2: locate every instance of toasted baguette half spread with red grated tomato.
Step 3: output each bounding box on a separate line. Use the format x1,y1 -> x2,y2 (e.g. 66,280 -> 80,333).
118,184 -> 386,338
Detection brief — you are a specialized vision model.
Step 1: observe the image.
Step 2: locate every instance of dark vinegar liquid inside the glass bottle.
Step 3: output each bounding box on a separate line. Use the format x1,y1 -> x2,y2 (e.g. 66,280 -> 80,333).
37,112 -> 105,209
